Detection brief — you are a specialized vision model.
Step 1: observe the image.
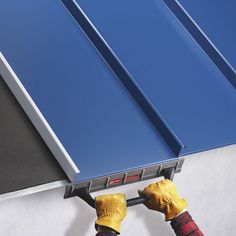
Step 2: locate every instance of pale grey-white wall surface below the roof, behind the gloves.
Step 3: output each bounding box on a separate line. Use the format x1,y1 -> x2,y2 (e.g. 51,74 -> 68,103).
0,145 -> 236,236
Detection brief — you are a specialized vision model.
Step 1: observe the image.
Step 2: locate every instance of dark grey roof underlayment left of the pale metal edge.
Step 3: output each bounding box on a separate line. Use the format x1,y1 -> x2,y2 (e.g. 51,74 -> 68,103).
0,76 -> 67,194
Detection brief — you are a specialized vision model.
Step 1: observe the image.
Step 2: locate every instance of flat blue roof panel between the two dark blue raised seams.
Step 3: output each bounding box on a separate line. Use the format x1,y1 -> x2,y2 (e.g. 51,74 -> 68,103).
68,0 -> 236,155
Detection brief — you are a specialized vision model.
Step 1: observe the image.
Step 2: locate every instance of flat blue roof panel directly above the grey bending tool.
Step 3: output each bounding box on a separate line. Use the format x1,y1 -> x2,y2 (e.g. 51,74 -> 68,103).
0,0 -> 176,181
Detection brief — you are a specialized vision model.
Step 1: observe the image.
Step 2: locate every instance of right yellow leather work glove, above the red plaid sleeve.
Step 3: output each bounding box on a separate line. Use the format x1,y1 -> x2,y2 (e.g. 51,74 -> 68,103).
139,179 -> 187,221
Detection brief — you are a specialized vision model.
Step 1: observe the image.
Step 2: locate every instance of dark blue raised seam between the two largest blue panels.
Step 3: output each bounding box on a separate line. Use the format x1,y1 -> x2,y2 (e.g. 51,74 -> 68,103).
62,0 -> 184,155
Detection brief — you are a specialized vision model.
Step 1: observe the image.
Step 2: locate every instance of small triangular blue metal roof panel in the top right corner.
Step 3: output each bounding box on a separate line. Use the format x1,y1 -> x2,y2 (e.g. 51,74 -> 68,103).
179,0 -> 236,71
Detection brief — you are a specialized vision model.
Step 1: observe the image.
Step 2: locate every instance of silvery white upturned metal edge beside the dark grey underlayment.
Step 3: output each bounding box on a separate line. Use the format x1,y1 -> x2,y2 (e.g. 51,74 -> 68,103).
0,52 -> 79,182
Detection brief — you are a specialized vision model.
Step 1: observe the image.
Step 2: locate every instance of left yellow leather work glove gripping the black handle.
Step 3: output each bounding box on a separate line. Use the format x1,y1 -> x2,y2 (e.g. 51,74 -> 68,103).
95,194 -> 127,233
